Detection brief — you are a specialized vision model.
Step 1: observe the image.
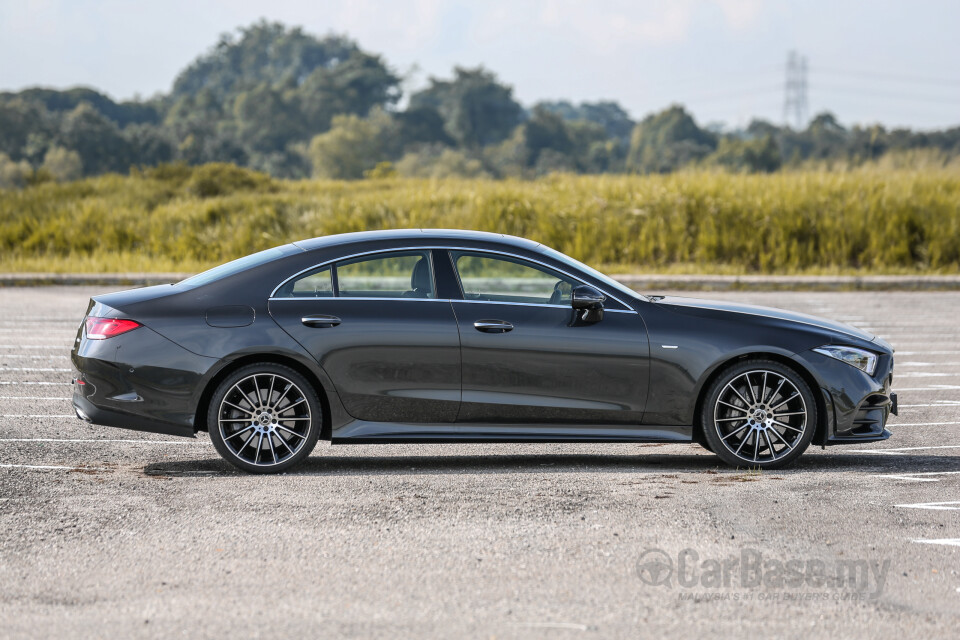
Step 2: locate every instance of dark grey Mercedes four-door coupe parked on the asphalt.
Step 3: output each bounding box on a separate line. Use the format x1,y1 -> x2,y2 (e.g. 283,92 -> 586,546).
71,229 -> 897,473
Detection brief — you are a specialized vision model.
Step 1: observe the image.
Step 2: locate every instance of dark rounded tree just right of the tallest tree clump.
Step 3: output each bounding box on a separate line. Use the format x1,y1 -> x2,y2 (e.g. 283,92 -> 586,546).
410,67 -> 523,148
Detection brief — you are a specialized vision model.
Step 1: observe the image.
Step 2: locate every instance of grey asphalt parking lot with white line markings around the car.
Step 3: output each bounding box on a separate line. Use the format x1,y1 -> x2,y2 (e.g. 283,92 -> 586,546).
0,287 -> 960,638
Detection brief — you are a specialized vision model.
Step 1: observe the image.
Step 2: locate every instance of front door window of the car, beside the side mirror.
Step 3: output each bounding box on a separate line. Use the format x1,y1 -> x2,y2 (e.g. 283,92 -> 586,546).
451,251 -> 574,306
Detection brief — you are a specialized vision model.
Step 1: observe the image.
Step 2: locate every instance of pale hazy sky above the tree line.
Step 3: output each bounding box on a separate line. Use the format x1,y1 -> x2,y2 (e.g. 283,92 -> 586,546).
0,0 -> 960,129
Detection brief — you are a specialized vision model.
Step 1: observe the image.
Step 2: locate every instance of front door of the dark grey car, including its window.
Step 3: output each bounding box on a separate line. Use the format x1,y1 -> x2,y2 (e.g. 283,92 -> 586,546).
450,250 -> 649,425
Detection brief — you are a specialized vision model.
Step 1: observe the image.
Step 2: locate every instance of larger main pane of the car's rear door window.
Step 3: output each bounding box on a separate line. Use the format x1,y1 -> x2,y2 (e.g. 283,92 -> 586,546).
336,251 -> 436,298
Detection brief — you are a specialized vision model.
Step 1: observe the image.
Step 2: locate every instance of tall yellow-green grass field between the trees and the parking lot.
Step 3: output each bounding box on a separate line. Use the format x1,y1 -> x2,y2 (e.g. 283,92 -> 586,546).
0,165 -> 960,273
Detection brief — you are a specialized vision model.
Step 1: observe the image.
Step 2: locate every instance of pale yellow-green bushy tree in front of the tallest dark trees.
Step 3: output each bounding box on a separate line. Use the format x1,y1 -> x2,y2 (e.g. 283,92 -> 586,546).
310,110 -> 396,180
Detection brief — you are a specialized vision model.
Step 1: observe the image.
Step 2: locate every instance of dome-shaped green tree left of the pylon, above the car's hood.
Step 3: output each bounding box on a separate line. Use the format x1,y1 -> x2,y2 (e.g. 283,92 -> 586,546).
627,105 -> 717,173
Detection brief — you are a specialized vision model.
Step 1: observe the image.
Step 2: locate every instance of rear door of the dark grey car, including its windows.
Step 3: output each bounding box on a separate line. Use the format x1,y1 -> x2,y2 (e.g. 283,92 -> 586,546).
270,250 -> 460,423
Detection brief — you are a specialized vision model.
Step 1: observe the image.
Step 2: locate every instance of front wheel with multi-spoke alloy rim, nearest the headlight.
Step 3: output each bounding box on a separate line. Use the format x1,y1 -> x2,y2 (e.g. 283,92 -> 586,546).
700,359 -> 817,469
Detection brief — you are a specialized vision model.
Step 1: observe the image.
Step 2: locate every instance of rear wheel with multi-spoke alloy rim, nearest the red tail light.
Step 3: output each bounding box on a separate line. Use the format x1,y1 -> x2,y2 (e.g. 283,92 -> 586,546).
207,363 -> 323,473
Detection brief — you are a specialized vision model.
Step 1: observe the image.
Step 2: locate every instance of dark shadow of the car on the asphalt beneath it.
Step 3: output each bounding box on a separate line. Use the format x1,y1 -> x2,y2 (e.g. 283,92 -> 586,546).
143,452 -> 960,477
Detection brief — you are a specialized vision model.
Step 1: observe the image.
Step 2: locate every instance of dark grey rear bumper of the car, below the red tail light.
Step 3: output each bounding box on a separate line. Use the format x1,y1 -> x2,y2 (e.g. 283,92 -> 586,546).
71,327 -> 218,438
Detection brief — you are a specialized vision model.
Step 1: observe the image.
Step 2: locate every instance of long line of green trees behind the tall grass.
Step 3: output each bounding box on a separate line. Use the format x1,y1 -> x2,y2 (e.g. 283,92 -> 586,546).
0,22 -> 960,188
